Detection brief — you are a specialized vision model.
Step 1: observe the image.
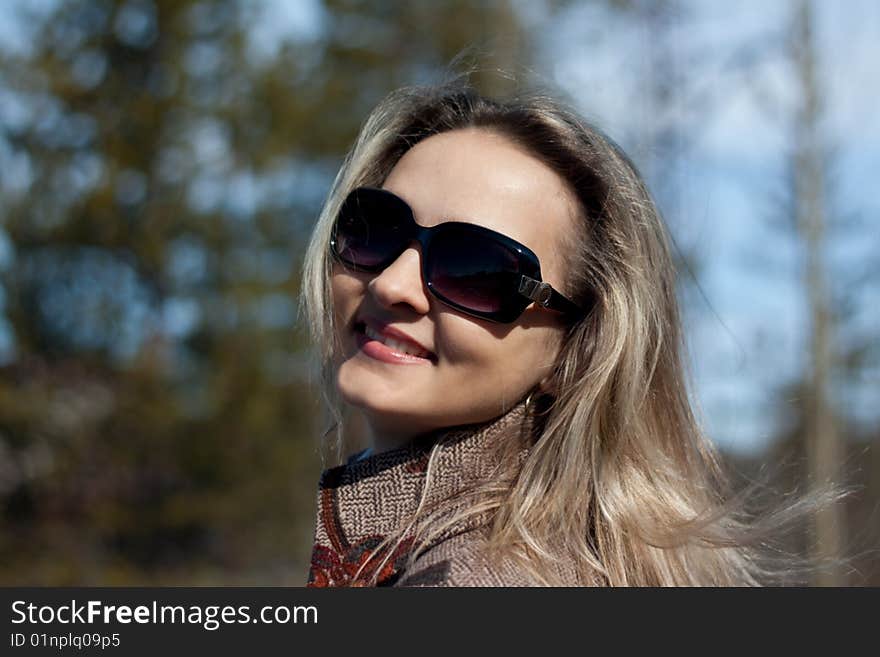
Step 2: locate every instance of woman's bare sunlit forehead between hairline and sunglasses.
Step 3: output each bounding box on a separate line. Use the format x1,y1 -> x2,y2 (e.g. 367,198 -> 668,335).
383,128 -> 574,282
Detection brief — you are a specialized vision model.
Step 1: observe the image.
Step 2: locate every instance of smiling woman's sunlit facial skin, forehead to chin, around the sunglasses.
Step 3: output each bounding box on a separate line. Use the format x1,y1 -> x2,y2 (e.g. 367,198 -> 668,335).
331,128 -> 576,451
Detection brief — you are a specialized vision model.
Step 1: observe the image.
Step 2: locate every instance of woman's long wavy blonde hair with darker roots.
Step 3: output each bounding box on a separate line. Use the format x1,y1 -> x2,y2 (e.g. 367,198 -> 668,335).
301,77 -> 816,586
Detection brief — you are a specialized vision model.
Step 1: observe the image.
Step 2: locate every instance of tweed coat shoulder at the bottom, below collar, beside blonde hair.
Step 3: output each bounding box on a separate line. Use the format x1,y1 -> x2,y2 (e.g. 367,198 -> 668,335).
395,532 -> 540,587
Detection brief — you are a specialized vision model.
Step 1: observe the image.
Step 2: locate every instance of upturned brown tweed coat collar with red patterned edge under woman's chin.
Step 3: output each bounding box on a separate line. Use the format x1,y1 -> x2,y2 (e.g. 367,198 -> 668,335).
308,401 -> 534,586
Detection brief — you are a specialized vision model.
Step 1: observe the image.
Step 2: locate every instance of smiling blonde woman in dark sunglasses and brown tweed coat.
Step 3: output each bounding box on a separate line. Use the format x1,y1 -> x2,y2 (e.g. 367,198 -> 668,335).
303,75 -> 776,586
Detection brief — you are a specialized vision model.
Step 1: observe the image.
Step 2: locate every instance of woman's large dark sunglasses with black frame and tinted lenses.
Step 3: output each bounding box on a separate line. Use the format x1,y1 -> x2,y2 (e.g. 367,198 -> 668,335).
330,187 -> 585,323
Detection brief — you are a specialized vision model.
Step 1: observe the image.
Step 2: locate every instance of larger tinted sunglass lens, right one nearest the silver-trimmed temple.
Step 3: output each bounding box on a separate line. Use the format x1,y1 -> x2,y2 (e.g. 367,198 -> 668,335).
427,231 -> 518,313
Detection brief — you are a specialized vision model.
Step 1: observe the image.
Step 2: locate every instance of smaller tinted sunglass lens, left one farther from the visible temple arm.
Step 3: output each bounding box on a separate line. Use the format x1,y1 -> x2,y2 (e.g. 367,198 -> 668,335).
334,192 -> 408,269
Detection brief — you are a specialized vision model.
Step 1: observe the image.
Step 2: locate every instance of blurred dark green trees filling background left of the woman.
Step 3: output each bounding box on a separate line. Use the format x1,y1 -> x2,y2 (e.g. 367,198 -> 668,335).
0,0 -> 528,584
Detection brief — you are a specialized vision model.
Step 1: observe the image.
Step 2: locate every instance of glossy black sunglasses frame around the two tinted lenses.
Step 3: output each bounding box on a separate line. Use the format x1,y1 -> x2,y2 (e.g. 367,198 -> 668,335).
330,187 -> 585,324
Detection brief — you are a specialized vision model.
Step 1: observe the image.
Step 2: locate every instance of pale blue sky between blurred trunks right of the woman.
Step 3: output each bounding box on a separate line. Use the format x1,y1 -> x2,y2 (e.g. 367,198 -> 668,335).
545,0 -> 880,452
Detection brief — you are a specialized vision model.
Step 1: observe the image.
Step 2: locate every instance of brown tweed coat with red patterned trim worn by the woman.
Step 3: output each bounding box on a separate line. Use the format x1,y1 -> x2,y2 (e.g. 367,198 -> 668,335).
308,402 -> 578,587
